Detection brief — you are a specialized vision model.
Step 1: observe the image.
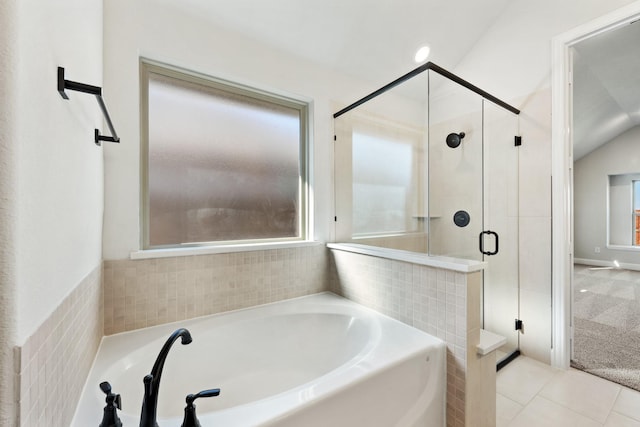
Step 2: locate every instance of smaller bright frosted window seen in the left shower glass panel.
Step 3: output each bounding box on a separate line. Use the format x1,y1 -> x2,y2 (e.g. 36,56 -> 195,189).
352,131 -> 415,236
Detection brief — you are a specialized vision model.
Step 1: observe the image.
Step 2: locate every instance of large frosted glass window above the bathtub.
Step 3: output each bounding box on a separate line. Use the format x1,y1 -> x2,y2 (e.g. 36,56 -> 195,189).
145,68 -> 307,247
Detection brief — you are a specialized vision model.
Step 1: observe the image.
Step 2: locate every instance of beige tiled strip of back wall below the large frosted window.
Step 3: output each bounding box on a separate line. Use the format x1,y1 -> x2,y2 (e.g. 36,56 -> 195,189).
104,244 -> 328,335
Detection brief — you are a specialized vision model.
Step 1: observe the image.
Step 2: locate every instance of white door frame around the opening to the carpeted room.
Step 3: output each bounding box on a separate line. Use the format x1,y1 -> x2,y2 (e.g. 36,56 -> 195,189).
551,1 -> 640,369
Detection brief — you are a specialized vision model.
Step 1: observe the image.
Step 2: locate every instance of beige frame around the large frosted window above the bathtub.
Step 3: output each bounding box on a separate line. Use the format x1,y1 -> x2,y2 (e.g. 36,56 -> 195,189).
139,58 -> 312,251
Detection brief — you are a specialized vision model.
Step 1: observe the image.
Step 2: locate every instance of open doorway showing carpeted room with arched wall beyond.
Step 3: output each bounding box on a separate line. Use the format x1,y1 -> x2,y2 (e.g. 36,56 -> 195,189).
570,22 -> 640,390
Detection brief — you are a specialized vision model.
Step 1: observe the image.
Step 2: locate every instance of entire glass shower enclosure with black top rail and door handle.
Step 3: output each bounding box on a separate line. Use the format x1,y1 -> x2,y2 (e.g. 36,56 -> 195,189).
334,62 -> 521,366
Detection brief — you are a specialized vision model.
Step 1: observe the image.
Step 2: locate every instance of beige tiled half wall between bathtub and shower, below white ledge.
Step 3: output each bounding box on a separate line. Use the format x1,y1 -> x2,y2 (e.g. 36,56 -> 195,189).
331,249 -> 496,427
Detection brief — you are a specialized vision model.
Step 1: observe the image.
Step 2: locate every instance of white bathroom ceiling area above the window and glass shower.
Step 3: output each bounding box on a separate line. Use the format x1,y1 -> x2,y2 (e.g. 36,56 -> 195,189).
174,0 -> 508,85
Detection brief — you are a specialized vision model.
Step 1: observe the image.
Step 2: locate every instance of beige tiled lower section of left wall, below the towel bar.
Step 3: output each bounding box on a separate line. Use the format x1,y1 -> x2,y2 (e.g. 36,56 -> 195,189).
15,265 -> 103,427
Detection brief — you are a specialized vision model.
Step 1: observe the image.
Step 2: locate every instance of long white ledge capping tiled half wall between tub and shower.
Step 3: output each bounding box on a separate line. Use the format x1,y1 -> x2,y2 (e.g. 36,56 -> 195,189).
327,243 -> 487,273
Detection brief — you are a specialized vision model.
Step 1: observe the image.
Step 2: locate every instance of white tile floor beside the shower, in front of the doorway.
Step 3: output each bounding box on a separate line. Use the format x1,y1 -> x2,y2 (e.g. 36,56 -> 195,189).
496,356 -> 640,427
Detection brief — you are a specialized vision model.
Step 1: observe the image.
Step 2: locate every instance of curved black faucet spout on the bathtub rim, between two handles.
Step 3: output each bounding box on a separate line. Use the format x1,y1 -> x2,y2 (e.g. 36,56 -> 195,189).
140,328 -> 192,427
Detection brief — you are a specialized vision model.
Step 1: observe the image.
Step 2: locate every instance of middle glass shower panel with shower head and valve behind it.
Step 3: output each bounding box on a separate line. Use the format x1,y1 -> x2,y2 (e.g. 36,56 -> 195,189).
428,71 -> 484,261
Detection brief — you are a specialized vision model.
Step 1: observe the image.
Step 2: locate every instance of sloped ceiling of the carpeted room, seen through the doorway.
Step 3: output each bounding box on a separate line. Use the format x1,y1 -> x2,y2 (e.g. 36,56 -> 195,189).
573,22 -> 640,160
